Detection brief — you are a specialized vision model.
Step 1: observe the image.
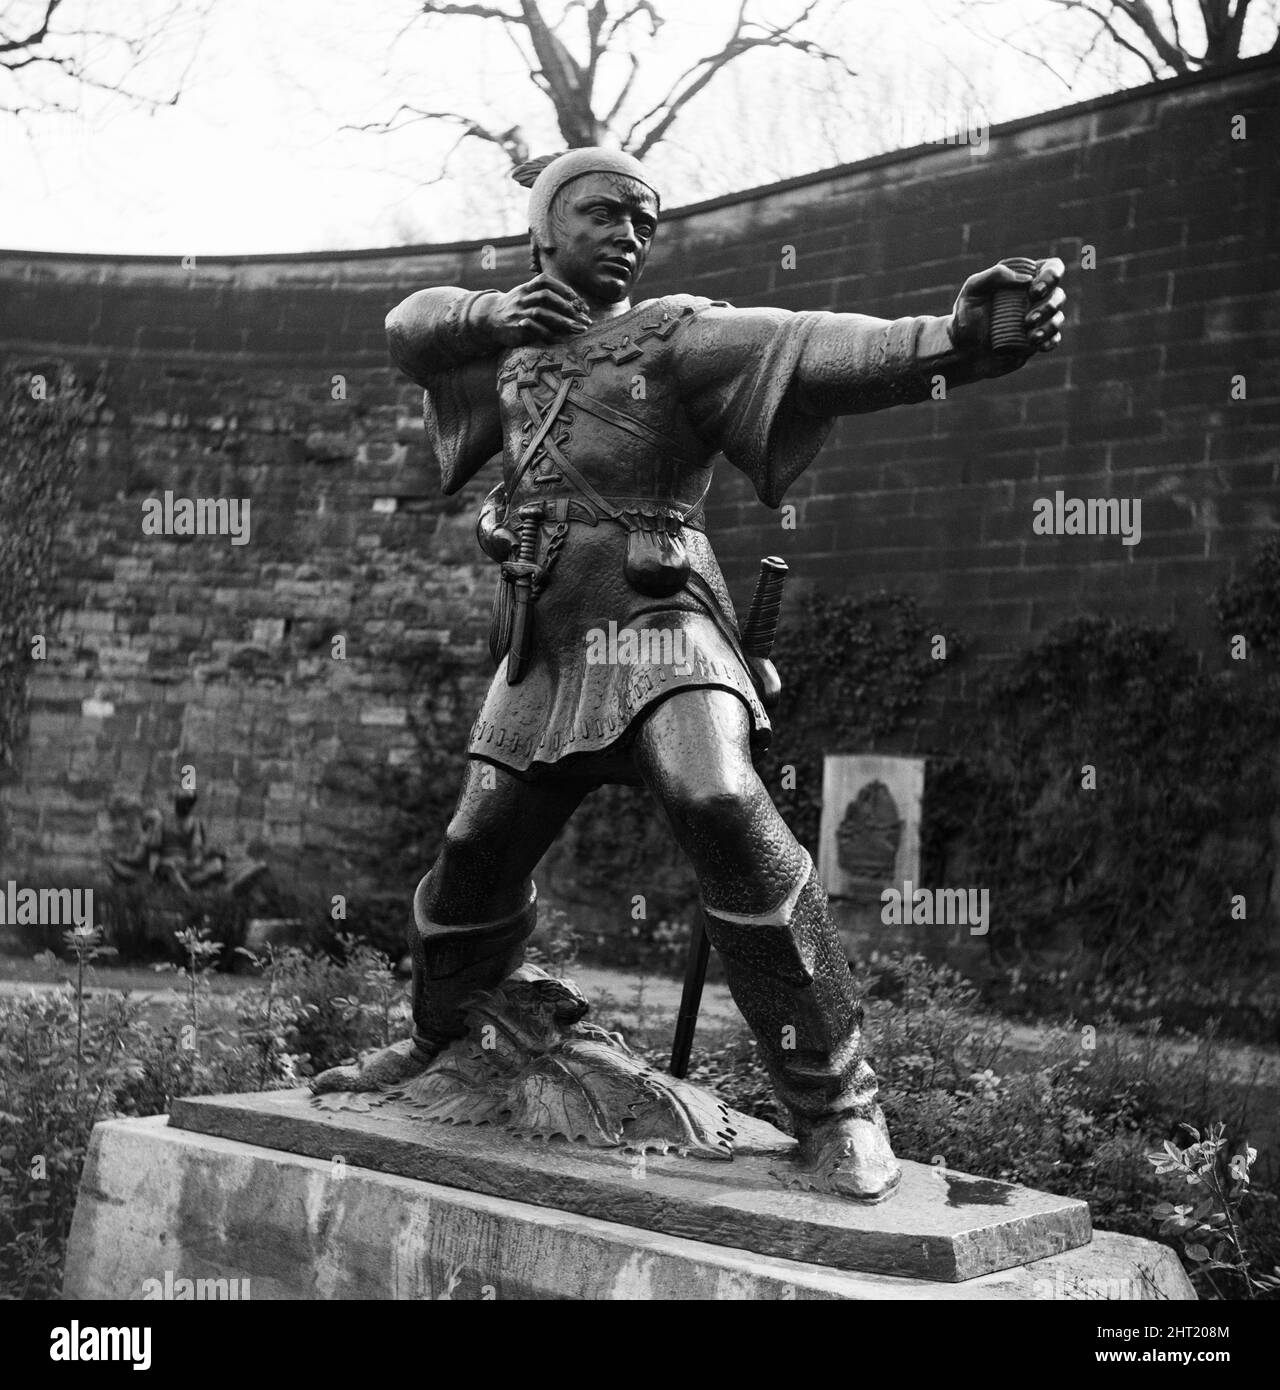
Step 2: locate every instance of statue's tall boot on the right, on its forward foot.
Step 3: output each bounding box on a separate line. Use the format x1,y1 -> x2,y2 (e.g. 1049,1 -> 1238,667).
702,855 -> 902,1202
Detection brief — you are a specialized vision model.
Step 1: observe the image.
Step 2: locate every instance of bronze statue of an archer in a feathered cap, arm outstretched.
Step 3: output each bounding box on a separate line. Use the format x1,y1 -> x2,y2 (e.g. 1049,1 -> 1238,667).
318,149 -> 1063,1201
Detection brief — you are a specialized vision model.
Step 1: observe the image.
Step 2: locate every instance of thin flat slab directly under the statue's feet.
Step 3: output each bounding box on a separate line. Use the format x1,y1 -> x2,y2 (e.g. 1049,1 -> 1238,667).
171,1091 -> 1090,1283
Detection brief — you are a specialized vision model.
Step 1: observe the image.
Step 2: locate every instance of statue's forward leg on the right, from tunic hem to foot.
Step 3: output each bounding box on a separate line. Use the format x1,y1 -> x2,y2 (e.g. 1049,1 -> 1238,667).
635,689 -> 901,1201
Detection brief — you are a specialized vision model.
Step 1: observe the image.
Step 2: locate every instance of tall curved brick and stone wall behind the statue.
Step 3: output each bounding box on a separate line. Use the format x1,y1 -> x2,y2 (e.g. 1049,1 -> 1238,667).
0,61 -> 1280,887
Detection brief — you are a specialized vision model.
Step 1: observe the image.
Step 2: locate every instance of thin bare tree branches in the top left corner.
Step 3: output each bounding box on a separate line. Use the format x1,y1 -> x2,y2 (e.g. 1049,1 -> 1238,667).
0,0 -> 210,115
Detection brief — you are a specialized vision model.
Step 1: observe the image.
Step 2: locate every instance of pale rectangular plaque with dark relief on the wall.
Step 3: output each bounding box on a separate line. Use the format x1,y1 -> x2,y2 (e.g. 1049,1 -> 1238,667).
817,753 -> 924,906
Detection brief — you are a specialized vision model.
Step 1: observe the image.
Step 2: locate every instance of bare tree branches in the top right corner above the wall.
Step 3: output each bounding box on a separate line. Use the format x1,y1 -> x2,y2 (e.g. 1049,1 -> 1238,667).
960,0 -> 1280,81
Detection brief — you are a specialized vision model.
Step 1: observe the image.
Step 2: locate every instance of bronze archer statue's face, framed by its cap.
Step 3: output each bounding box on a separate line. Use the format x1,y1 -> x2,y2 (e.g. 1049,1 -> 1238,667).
542,174 -> 657,304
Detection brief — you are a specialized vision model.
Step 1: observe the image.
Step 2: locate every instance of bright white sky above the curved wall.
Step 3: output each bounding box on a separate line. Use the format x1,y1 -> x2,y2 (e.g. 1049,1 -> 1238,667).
0,0 -> 1267,256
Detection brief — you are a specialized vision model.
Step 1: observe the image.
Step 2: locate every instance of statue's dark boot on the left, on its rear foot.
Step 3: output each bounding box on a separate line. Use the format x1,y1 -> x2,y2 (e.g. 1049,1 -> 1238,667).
311,874 -> 538,1095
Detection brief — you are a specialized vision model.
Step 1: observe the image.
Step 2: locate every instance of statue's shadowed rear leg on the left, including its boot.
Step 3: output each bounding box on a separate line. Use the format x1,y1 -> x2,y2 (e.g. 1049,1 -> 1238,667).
311,759 -> 598,1093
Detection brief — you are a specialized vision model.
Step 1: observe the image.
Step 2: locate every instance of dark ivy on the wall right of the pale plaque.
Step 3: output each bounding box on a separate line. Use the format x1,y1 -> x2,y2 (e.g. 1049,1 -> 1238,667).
924,616 -> 1280,972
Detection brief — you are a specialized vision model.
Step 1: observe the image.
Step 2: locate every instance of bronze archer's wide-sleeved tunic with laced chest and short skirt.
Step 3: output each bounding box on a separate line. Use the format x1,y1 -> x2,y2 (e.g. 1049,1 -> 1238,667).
388,289 -> 963,783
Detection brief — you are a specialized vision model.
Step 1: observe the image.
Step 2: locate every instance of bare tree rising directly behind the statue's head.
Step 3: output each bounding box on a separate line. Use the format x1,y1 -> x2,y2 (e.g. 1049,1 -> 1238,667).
353,0 -> 856,165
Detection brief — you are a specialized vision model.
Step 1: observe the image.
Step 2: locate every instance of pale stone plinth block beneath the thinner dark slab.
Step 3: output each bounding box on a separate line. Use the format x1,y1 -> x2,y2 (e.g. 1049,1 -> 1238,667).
64,1097 -> 1194,1301
